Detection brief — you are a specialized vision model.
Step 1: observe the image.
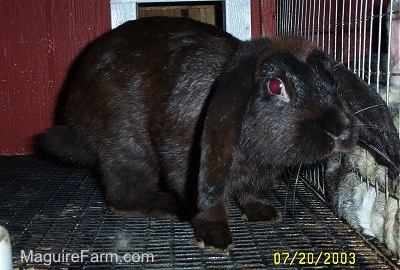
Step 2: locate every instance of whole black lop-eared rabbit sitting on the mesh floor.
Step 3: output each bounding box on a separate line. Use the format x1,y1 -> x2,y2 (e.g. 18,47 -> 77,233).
40,17 -> 399,250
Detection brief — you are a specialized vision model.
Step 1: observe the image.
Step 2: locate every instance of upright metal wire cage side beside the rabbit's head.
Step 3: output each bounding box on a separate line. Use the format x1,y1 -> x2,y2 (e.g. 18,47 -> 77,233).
276,0 -> 400,202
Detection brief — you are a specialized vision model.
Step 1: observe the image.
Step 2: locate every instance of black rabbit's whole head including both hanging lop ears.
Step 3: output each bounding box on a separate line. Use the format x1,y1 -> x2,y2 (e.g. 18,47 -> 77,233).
199,38 -> 400,209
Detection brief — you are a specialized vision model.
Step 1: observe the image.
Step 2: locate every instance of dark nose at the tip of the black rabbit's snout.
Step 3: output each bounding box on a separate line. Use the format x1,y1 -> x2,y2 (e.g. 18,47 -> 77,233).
322,109 -> 350,140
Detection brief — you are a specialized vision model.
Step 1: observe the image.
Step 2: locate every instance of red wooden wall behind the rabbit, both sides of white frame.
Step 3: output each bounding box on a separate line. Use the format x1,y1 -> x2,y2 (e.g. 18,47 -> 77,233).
0,0 -> 275,155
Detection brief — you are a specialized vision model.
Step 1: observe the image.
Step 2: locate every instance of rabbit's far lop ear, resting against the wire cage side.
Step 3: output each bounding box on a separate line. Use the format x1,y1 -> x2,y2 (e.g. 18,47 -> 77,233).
333,64 -> 400,179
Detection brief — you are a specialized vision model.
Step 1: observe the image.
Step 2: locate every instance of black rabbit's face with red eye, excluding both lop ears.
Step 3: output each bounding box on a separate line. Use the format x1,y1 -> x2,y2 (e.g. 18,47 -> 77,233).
243,38 -> 358,166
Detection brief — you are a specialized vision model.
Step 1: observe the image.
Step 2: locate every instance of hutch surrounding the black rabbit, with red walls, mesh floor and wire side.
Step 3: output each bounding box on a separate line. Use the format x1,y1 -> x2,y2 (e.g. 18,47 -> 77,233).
0,0 -> 400,270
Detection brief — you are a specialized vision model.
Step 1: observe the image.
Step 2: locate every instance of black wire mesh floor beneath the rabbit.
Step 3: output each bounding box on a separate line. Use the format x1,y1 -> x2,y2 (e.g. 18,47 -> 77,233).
0,156 -> 400,269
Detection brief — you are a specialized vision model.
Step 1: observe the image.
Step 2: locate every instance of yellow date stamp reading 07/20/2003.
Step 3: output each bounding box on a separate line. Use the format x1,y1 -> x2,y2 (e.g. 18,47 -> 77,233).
274,251 -> 356,266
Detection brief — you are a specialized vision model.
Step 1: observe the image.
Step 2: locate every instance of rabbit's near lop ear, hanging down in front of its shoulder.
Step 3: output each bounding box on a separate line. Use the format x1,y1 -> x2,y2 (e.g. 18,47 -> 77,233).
197,40 -> 265,210
